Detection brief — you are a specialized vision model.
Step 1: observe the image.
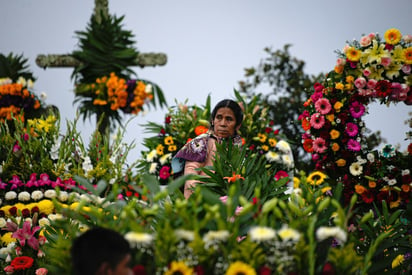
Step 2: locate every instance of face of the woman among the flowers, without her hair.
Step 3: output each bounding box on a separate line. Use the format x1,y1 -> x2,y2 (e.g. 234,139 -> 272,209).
213,107 -> 240,138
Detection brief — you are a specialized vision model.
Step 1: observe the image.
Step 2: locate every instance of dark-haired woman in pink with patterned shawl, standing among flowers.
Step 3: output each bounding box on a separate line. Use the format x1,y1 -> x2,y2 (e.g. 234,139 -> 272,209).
172,99 -> 243,198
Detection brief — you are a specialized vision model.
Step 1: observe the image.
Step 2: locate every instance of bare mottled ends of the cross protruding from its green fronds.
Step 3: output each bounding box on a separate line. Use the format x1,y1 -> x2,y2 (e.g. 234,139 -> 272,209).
36,0 -> 167,69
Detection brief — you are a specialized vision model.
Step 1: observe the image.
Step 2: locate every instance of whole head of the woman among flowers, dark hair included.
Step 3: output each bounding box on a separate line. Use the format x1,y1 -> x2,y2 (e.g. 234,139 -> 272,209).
210,99 -> 243,138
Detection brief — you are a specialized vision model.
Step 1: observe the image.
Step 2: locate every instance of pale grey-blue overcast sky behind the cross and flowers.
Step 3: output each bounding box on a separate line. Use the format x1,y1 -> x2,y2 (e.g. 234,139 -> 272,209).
0,0 -> 412,160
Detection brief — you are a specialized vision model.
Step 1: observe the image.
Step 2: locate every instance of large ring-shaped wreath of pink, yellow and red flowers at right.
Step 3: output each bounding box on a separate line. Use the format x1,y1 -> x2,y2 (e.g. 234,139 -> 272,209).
299,29 -> 412,209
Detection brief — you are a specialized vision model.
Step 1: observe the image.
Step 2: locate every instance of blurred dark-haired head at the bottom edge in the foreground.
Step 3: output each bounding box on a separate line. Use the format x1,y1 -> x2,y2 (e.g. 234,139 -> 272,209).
70,227 -> 133,275
